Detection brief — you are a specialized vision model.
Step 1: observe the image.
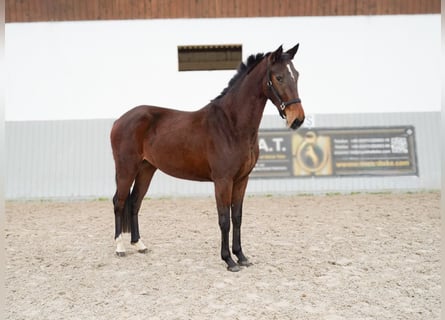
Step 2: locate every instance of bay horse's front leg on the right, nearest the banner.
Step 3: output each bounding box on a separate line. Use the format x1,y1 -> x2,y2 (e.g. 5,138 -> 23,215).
232,178 -> 252,267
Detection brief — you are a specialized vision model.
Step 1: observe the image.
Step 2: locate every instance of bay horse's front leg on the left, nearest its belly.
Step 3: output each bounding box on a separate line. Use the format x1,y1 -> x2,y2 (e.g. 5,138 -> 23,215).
215,180 -> 240,272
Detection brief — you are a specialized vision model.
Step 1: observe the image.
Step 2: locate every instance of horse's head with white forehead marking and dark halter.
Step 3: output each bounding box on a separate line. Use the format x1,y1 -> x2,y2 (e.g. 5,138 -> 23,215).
264,44 -> 304,130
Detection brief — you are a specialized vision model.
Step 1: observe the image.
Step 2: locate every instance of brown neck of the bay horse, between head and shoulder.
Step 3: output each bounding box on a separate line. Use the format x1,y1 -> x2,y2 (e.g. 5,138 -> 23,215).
219,62 -> 267,133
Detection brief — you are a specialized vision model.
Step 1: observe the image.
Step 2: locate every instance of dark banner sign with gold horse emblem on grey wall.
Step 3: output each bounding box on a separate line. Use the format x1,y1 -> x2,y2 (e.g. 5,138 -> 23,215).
251,126 -> 418,178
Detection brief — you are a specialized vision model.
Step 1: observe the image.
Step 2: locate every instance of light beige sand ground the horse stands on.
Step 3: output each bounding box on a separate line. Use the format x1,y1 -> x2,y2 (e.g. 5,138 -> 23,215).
5,192 -> 441,320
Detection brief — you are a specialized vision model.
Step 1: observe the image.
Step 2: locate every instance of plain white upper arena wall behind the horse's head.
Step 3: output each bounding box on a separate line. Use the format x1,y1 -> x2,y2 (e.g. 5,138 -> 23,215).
5,14 -> 441,121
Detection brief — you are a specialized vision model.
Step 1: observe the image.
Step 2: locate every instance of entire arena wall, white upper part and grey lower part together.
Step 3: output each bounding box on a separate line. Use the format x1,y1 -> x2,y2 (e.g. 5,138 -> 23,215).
5,13 -> 440,199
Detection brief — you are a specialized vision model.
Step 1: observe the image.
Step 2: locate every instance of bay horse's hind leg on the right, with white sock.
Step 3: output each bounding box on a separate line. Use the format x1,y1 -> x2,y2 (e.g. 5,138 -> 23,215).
130,161 -> 156,253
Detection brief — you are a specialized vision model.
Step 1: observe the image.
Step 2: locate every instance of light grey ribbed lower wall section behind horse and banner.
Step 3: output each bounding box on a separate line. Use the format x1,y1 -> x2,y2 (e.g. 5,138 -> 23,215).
5,112 -> 440,199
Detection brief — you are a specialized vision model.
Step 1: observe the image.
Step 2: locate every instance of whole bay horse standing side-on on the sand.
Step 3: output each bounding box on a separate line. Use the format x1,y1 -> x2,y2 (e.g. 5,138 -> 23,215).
110,44 -> 305,271
